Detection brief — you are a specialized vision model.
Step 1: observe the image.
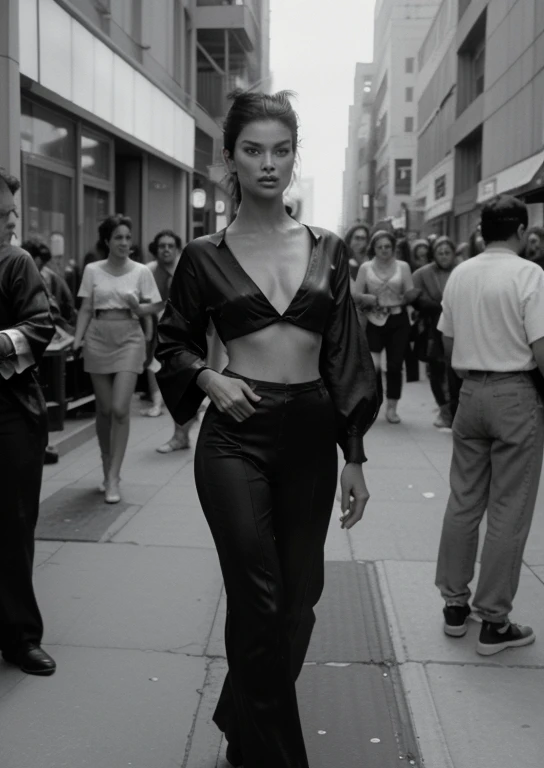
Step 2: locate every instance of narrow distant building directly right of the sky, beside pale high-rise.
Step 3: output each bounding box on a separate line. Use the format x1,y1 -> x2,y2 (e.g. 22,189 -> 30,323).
341,63 -> 374,232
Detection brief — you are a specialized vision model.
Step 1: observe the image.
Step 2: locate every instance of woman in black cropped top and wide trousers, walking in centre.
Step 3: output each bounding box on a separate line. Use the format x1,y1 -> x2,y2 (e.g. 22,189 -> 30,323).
156,91 -> 377,768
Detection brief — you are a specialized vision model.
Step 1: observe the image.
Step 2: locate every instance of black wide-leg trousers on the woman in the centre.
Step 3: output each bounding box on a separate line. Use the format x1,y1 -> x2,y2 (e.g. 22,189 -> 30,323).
195,371 -> 338,768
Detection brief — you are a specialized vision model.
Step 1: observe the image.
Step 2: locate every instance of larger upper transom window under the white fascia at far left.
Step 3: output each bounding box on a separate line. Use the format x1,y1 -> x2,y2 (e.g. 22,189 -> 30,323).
21,99 -> 75,167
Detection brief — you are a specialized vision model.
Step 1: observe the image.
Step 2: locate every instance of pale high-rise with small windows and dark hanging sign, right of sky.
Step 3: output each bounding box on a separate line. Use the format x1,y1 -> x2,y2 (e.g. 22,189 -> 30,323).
374,0 -> 440,228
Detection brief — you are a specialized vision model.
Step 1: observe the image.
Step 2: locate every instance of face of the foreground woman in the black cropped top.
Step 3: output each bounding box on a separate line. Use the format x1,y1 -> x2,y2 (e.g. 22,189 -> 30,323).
225,120 -> 295,200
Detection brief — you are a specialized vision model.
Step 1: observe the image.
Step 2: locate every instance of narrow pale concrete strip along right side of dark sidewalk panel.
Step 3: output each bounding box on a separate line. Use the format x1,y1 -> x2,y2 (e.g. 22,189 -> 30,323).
375,561 -> 455,768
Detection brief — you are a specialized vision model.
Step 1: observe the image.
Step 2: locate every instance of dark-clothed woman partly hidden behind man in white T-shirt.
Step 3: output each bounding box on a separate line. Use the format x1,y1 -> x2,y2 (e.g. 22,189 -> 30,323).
413,235 -> 462,428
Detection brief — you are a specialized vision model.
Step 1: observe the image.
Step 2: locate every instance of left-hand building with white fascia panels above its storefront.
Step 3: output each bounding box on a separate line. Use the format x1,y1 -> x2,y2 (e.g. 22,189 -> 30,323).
0,0 -> 269,269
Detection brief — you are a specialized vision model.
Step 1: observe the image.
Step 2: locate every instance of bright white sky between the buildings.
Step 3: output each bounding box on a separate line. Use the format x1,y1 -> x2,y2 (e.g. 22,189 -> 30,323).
270,0 -> 374,231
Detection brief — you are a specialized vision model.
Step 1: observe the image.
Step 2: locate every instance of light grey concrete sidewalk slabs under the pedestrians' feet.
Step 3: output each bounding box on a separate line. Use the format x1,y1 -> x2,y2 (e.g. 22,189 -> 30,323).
0,382 -> 544,768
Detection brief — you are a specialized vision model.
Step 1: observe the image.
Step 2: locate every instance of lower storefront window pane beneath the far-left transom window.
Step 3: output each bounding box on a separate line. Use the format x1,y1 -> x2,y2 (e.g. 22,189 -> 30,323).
23,165 -> 74,275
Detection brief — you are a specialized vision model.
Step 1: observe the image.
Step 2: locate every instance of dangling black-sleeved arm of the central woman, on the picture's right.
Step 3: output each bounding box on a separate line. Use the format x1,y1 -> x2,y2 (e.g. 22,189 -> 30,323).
320,239 -> 380,528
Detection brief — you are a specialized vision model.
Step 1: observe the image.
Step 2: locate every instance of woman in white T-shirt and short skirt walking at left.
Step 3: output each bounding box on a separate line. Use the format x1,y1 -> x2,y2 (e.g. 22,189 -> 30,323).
74,214 -> 161,504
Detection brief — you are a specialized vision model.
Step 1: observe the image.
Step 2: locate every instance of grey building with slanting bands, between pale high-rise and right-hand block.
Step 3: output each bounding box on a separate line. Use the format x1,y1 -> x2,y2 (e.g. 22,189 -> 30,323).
411,0 -> 458,235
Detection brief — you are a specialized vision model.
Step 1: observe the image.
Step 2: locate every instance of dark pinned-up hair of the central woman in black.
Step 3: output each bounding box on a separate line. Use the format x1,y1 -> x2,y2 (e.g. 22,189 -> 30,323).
223,88 -> 298,206
